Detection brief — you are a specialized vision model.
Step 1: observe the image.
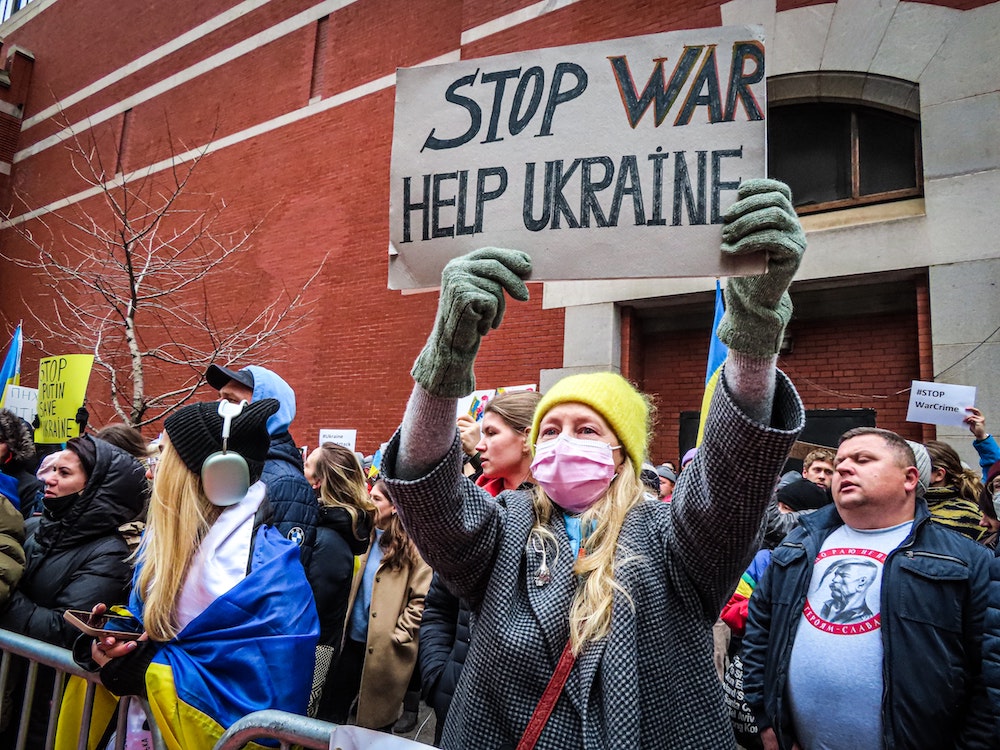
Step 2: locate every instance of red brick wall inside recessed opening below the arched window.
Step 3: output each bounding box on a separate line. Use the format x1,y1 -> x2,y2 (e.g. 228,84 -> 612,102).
642,313 -> 922,463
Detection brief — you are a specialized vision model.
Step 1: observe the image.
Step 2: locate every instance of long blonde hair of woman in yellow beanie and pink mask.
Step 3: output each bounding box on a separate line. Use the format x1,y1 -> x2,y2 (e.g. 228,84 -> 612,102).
529,455 -> 645,655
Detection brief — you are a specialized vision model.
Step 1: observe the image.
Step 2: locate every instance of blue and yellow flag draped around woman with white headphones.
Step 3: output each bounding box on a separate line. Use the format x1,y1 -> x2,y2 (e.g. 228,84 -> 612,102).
56,528 -> 319,750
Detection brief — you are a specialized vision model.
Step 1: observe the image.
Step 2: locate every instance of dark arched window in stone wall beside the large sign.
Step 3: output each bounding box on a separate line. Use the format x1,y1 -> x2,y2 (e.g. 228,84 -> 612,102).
767,73 -> 923,214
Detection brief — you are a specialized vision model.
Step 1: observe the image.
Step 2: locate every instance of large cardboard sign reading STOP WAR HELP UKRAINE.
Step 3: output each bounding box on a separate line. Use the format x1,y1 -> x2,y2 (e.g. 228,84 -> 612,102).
389,26 -> 766,289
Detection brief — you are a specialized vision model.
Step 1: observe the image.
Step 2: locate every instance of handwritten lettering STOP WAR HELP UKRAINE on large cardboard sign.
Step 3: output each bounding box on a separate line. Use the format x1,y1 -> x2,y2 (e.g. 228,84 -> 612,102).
401,41 -> 764,242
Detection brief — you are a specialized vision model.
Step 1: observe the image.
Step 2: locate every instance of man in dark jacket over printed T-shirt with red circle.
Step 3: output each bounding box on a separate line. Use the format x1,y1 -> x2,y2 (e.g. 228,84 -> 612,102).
743,427 -> 995,750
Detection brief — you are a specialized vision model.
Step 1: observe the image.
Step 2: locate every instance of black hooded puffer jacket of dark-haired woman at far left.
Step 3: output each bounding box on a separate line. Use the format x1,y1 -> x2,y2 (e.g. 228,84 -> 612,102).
0,436 -> 148,648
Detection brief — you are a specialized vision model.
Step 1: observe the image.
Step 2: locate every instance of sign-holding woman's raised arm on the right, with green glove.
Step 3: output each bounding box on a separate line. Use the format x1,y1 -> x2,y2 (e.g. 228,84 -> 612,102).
672,180 -> 806,617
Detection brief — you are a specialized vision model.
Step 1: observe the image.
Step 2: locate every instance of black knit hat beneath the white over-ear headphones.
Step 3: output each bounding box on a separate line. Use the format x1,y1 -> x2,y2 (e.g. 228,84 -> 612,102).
163,398 -> 280,484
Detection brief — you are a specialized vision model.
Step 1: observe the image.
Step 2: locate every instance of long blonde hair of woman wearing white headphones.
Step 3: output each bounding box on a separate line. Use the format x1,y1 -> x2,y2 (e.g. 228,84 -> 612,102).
136,435 -> 222,641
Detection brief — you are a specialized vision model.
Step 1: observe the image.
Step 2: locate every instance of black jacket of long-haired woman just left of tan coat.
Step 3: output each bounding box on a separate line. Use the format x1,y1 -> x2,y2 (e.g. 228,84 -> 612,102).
306,505 -> 372,659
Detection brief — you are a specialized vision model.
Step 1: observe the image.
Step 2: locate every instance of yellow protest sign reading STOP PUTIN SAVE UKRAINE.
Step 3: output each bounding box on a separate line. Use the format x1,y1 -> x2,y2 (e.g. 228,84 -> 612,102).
35,354 -> 94,443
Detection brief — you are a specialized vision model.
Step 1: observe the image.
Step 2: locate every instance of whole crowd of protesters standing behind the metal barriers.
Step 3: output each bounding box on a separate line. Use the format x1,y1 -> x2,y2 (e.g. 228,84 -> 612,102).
0,180 -> 1000,750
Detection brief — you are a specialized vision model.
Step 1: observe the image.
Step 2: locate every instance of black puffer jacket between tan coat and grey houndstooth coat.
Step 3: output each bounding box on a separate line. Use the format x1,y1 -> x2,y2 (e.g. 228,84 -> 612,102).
417,573 -> 470,745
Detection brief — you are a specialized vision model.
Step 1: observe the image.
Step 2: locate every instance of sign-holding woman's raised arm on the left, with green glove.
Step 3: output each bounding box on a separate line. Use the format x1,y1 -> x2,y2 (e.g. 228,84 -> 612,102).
382,248 -> 531,599
